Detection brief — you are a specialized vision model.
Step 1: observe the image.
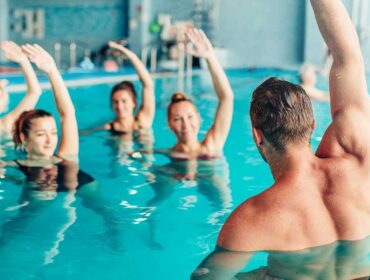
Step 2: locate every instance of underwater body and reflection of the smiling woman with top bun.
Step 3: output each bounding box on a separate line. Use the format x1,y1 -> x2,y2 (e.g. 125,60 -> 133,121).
140,158 -> 232,249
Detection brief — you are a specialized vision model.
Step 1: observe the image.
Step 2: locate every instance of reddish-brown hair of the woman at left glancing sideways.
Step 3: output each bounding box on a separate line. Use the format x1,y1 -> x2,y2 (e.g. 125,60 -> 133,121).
13,110 -> 53,149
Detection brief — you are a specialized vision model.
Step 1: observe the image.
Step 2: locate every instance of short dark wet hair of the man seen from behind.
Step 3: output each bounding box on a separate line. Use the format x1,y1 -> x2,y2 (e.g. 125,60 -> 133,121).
250,78 -> 314,151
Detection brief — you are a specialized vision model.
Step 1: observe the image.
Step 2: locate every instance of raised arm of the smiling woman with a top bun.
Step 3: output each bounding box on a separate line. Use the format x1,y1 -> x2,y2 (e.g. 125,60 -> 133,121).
186,28 -> 234,150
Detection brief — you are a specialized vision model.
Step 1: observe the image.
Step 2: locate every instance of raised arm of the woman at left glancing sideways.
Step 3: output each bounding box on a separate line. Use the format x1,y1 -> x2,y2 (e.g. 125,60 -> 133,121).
22,44 -> 79,160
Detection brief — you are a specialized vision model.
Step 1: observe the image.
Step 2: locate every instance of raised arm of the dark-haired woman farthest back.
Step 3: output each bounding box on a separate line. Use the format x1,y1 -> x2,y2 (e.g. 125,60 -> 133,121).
109,41 -> 155,128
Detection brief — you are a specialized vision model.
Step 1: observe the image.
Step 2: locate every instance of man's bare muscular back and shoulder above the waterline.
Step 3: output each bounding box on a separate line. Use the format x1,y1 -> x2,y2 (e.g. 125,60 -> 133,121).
218,152 -> 370,251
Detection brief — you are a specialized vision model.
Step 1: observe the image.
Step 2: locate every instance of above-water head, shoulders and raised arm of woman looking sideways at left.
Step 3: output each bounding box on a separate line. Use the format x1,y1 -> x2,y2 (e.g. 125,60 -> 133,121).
13,45 -> 79,166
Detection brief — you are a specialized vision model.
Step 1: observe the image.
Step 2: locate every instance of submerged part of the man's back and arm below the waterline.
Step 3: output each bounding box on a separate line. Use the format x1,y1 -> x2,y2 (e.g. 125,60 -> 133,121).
192,236 -> 370,280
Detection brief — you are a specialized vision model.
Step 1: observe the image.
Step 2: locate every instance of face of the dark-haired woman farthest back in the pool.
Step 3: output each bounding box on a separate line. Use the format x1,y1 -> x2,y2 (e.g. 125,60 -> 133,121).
112,89 -> 136,118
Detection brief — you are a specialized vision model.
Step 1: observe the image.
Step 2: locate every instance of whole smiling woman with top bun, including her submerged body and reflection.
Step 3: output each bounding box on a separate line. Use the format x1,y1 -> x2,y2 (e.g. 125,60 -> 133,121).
126,29 -> 233,248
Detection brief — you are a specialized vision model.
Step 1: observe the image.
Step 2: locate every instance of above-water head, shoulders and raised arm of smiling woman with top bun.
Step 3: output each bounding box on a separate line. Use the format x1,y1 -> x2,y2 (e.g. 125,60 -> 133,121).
167,28 -> 233,159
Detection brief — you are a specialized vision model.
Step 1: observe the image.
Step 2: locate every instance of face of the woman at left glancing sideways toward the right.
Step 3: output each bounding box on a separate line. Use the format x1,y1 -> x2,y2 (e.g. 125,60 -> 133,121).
22,117 -> 58,158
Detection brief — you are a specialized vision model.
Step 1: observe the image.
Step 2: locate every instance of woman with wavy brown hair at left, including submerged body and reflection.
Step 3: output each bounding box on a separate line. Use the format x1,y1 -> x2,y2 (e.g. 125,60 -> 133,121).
0,45 -> 121,256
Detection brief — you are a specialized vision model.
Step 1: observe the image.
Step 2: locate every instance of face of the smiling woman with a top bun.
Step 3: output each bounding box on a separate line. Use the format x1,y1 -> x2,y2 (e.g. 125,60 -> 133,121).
168,101 -> 200,143
